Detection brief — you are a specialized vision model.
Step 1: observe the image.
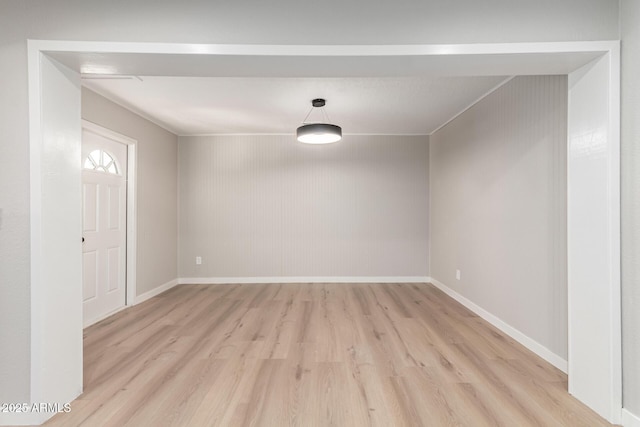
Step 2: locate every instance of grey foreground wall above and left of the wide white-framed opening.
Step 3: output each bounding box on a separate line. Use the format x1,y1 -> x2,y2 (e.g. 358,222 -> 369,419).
0,0 -> 624,422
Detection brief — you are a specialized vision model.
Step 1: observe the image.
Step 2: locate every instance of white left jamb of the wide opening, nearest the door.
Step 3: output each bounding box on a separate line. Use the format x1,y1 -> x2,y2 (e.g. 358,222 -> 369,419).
30,54 -> 83,422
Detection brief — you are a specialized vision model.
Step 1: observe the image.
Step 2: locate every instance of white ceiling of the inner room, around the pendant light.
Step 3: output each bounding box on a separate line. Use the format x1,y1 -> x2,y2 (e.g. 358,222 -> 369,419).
83,76 -> 505,135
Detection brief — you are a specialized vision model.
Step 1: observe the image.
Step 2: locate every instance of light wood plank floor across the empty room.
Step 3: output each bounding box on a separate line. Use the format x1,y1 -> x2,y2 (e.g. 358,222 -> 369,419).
46,284 -> 609,427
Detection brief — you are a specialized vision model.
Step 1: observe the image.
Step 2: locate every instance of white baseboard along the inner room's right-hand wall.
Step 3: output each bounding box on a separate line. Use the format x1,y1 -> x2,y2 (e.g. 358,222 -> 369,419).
430,278 -> 568,374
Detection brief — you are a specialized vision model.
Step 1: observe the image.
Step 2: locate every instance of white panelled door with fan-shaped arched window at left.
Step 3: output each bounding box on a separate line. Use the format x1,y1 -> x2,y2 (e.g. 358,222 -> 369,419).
82,129 -> 127,327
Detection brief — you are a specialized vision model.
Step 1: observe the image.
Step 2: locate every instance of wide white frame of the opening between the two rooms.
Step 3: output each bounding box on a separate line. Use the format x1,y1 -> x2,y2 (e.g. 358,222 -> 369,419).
29,41 -> 622,422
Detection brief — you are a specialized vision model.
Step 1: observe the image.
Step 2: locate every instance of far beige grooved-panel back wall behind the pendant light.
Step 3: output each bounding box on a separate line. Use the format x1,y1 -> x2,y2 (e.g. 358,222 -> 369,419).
179,135 -> 429,278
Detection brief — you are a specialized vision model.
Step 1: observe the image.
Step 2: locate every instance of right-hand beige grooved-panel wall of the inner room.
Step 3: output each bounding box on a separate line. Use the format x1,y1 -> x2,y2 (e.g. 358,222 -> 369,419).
430,76 -> 567,360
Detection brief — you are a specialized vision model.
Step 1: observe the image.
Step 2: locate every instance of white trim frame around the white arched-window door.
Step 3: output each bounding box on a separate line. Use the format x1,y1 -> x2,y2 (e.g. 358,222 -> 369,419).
82,119 -> 138,314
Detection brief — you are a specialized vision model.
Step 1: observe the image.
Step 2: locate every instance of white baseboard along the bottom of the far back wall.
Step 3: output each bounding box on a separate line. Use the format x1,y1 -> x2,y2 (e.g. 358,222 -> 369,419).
178,276 -> 429,285
